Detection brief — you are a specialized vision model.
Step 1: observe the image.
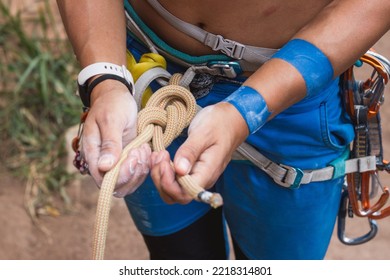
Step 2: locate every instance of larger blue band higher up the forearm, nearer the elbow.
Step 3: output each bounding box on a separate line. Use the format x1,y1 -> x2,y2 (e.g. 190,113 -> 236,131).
272,39 -> 334,96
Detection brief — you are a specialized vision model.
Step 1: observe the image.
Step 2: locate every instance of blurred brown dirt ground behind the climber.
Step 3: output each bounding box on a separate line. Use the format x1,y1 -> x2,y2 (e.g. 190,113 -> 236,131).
0,10 -> 390,260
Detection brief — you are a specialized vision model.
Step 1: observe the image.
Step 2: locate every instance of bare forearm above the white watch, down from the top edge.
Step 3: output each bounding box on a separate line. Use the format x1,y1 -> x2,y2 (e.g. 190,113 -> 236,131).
57,0 -> 126,68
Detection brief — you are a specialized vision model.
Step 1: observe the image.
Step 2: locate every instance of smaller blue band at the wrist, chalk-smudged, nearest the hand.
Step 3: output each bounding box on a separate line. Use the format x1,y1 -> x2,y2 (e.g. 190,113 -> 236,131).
222,86 -> 271,134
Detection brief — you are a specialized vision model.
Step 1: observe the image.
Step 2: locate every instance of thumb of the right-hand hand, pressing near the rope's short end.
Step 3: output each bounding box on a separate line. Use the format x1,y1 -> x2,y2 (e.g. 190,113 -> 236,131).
173,135 -> 205,176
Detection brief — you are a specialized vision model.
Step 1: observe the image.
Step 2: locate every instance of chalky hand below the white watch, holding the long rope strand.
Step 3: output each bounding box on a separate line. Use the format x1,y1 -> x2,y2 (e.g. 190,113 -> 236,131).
81,80 -> 151,197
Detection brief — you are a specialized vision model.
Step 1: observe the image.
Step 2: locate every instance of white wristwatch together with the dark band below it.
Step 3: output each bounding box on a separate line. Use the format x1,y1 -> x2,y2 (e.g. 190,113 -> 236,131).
77,62 -> 134,108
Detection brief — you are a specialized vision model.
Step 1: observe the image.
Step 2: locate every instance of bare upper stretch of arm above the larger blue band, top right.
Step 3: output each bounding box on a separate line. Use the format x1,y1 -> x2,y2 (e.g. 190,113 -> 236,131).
295,0 -> 390,76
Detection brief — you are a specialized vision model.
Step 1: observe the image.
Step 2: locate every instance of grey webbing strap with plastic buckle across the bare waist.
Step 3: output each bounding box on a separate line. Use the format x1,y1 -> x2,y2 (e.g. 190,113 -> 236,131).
148,0 -> 277,64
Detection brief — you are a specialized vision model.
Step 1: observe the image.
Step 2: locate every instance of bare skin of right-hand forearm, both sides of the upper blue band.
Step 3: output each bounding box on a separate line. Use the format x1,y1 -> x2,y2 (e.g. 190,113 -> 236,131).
245,0 -> 390,115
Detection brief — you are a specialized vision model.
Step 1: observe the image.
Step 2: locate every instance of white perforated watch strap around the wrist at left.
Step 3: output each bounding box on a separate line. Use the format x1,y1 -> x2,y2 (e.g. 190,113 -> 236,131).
77,62 -> 134,85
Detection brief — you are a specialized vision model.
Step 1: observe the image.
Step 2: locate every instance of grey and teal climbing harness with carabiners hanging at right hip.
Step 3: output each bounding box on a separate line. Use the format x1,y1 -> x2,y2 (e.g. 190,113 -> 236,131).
125,0 -> 390,244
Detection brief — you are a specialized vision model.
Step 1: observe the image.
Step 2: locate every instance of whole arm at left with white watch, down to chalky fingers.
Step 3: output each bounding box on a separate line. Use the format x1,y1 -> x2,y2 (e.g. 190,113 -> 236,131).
57,0 -> 143,188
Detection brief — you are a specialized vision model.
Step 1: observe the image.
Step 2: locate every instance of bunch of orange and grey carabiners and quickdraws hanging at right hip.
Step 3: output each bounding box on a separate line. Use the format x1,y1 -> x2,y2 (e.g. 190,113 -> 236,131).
338,50 -> 390,245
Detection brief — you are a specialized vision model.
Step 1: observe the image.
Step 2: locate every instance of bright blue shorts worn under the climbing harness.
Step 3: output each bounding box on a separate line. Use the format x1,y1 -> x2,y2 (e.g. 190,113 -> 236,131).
125,31 -> 354,259
